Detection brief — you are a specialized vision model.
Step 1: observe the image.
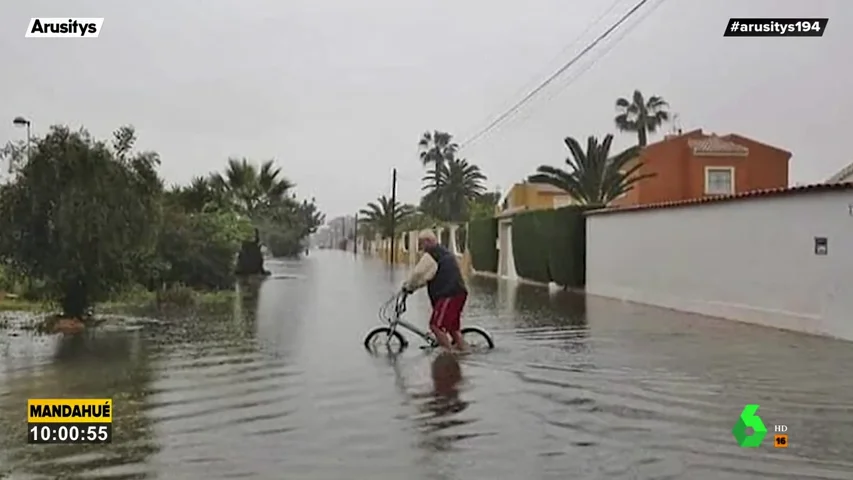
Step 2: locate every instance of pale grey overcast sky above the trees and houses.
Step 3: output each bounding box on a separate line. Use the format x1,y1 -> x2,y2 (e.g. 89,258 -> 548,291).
0,0 -> 853,217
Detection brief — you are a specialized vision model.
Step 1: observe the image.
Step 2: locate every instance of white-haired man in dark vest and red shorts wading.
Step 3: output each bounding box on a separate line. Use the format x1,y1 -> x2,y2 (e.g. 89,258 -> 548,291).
403,230 -> 468,351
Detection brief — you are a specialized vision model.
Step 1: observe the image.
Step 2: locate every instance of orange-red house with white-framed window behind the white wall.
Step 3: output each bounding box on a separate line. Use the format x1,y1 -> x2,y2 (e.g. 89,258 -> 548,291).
613,129 -> 791,206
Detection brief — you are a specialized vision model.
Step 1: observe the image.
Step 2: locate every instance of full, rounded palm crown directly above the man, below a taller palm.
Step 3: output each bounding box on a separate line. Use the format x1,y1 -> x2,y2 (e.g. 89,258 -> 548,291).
421,158 -> 486,222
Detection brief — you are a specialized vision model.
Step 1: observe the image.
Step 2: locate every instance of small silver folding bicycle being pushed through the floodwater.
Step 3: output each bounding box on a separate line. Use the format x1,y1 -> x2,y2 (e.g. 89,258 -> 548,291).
364,291 -> 495,353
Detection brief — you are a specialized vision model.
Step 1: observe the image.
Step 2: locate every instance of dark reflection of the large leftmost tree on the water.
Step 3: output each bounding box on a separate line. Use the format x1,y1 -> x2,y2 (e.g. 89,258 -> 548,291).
0,331 -> 159,479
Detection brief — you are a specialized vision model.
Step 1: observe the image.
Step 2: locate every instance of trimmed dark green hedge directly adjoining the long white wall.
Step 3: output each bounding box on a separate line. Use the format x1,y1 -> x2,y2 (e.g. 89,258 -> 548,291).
512,206 -> 586,288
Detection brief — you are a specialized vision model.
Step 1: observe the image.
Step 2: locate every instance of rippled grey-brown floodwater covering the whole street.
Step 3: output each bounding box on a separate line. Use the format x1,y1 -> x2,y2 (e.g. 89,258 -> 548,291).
0,251 -> 853,480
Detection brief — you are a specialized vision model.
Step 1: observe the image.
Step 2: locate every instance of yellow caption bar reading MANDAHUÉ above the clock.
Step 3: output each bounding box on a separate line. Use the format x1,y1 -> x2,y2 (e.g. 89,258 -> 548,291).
27,398 -> 113,423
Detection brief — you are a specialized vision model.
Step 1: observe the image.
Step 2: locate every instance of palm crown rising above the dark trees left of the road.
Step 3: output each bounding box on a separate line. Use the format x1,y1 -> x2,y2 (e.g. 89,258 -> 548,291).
210,158 -> 294,218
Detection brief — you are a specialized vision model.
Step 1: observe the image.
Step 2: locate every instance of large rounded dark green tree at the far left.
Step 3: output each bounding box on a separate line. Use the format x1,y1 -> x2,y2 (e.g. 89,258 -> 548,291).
0,126 -> 162,317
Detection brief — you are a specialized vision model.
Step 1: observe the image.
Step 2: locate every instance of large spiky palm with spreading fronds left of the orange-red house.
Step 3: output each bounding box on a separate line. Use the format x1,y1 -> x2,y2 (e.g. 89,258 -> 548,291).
527,135 -> 654,206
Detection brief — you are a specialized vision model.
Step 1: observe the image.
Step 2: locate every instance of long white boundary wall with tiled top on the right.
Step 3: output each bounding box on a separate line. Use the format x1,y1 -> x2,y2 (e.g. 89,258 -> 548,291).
586,190 -> 853,340
